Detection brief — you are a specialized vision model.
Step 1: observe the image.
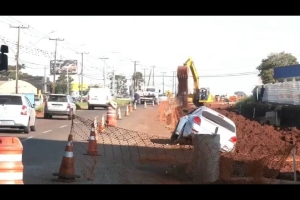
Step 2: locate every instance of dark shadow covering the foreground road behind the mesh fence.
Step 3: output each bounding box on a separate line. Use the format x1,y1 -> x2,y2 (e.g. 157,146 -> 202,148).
23,134 -> 193,184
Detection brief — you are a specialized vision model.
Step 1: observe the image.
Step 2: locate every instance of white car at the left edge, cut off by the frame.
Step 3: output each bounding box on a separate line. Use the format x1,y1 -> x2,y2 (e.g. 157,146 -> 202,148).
0,94 -> 36,133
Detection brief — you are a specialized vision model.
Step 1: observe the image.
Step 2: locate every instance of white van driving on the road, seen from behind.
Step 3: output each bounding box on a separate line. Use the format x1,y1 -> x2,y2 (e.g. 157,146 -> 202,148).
87,88 -> 112,110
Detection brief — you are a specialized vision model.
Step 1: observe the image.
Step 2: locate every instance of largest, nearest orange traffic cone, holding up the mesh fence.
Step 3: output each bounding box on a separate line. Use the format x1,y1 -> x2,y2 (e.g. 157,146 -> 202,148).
53,134 -> 80,182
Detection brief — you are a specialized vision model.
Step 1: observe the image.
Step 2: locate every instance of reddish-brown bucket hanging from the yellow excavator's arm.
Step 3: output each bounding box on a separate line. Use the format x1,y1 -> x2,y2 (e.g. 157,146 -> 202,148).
177,66 -> 189,107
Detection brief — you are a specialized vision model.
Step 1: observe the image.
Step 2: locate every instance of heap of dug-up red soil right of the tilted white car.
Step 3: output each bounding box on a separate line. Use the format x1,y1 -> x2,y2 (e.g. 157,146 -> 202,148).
176,105 -> 300,181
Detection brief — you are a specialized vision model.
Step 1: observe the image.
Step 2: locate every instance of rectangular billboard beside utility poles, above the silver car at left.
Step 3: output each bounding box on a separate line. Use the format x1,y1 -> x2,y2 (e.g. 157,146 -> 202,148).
50,60 -> 78,74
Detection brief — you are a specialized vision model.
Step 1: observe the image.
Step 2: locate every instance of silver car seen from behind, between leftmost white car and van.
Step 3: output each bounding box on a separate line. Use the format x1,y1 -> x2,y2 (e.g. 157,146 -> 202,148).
44,94 -> 76,120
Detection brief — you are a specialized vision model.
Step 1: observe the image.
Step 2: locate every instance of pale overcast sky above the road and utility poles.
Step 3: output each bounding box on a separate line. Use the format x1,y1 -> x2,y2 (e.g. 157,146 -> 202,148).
0,16 -> 300,95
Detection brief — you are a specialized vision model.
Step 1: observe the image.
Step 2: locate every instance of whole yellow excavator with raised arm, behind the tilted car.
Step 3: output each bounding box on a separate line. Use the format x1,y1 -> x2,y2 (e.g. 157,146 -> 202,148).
177,58 -> 214,107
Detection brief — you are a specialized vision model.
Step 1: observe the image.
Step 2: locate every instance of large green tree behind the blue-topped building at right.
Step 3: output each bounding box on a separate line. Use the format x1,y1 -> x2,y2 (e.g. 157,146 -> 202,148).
256,51 -> 299,84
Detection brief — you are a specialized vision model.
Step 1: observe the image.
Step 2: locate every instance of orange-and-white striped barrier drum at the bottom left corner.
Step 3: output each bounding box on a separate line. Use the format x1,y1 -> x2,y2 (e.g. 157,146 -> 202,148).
0,137 -> 24,184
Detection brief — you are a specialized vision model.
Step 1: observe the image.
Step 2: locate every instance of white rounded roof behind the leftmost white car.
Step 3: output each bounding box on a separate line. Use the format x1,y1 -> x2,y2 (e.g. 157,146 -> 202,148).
0,80 -> 38,94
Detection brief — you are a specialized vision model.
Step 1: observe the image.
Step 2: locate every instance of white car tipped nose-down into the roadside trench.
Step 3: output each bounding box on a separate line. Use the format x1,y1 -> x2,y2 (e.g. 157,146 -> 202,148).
171,106 -> 237,152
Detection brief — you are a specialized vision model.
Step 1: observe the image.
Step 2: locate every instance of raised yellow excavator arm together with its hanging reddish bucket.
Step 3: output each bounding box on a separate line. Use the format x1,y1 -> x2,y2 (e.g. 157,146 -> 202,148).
177,58 -> 203,107
